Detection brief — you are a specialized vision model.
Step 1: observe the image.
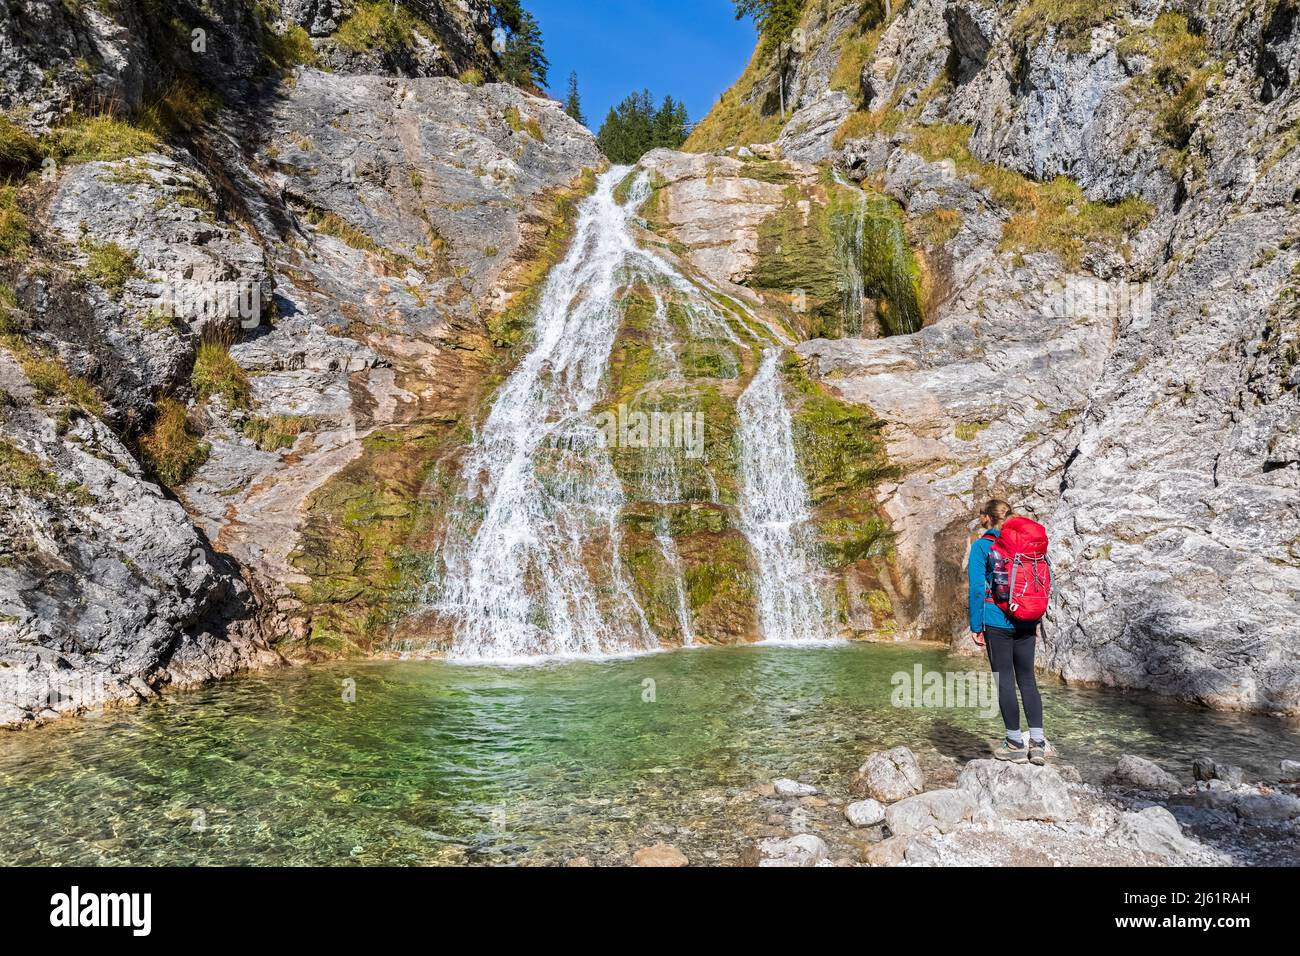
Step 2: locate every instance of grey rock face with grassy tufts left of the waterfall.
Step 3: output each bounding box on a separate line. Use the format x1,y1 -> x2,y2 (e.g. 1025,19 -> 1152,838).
0,0 -> 603,724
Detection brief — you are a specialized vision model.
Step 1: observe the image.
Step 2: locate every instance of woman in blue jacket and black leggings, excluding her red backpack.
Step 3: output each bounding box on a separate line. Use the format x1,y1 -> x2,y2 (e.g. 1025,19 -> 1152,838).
967,498 -> 1047,765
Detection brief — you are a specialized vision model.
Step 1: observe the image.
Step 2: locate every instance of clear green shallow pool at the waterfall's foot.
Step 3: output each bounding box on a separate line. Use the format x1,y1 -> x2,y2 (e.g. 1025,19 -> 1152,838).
0,645 -> 1300,865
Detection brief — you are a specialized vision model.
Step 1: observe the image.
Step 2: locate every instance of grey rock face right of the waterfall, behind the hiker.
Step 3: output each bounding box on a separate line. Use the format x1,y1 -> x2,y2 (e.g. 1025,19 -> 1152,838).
705,0 -> 1300,713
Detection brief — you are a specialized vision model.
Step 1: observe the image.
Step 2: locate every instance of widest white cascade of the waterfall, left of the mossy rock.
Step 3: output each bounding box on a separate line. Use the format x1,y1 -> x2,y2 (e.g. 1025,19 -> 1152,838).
436,166 -> 657,659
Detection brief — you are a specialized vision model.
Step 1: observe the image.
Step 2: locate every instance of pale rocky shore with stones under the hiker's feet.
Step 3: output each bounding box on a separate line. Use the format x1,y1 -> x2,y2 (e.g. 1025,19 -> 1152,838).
621,747 -> 1300,866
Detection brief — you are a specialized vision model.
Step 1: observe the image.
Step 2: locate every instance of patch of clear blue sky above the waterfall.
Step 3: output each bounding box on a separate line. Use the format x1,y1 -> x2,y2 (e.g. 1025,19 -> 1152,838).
524,0 -> 755,131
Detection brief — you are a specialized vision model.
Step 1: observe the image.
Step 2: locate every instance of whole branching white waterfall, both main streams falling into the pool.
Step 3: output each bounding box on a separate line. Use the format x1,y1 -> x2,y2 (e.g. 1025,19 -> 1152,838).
430,168 -> 828,659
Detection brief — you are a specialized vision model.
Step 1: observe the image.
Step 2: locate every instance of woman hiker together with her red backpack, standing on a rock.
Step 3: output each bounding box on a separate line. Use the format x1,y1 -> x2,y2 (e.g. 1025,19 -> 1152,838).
967,498 -> 1052,766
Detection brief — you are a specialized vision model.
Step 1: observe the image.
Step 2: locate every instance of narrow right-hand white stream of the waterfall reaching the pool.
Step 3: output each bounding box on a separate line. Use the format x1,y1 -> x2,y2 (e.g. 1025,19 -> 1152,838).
736,349 -> 833,643
